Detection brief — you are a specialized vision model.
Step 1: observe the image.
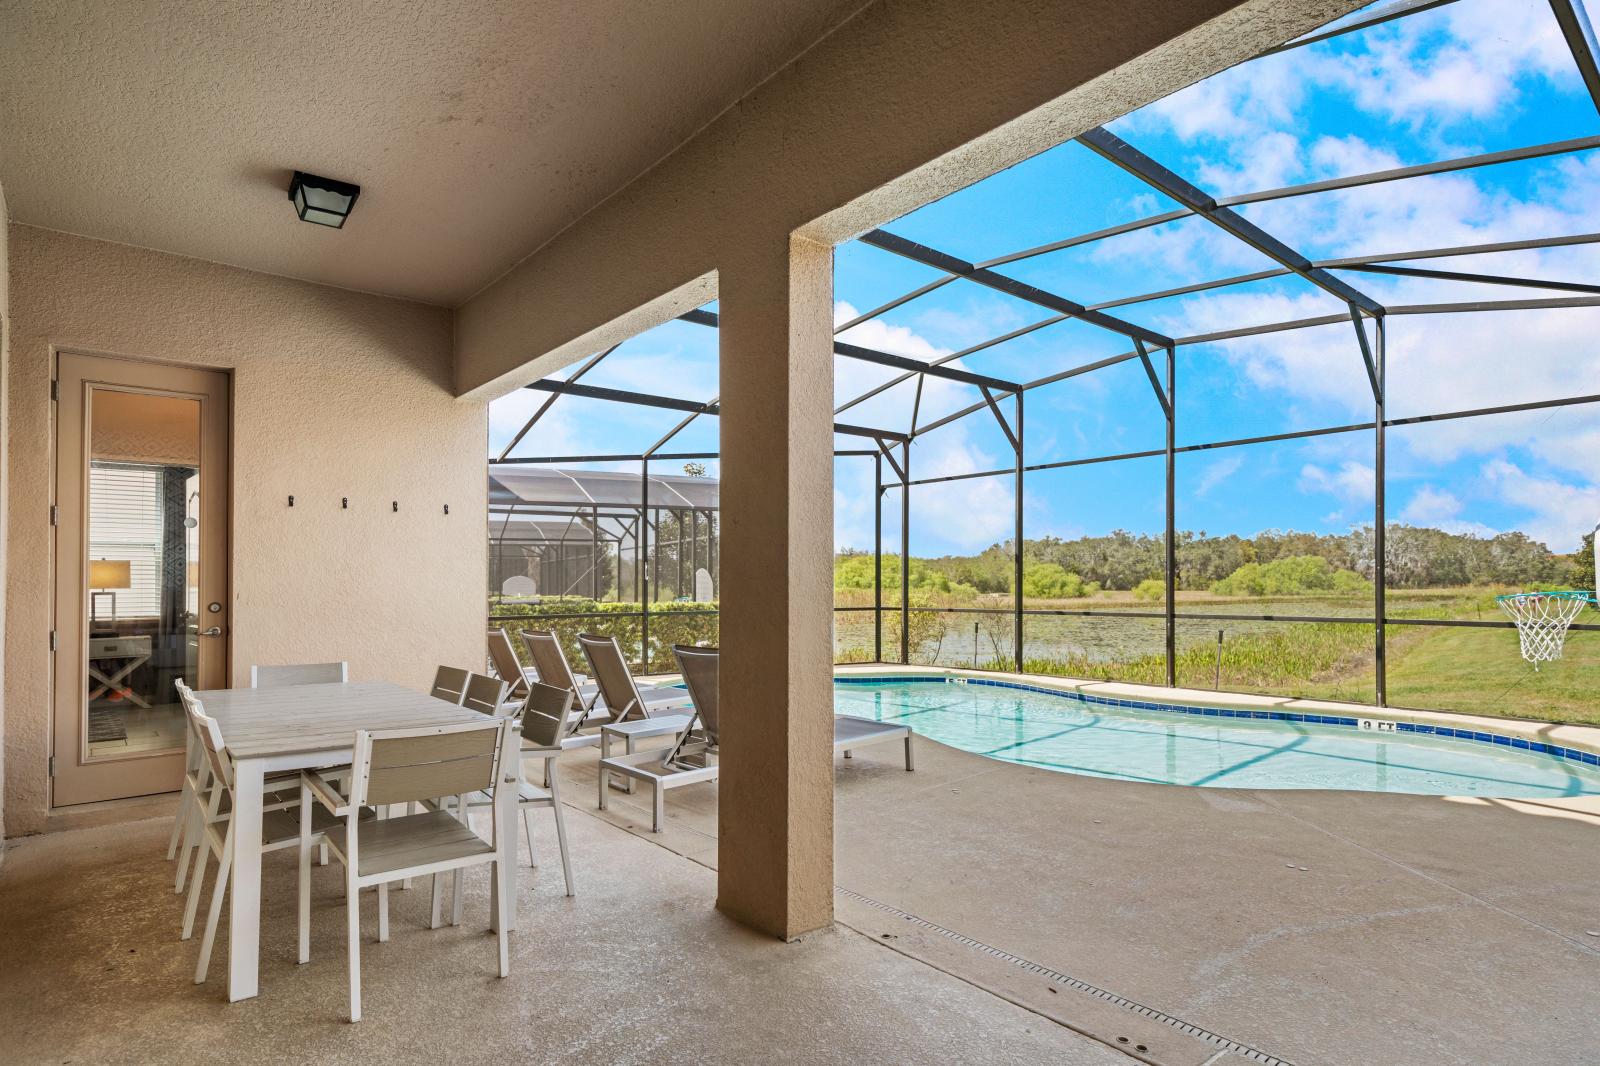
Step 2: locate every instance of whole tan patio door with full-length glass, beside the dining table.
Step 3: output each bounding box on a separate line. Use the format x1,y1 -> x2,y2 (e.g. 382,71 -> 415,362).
51,354 -> 229,807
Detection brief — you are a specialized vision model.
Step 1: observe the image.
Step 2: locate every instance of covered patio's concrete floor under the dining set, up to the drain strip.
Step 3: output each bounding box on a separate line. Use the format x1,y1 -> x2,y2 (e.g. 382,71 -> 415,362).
0,797 -> 1128,1066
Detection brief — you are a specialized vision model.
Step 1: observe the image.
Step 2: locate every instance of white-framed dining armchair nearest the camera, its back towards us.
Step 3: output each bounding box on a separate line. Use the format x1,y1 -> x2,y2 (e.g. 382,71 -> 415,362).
299,717 -> 517,1021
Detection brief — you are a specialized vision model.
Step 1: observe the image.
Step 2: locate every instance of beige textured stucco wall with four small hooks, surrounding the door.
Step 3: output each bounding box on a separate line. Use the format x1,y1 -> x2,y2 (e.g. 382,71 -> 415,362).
5,226 -> 486,836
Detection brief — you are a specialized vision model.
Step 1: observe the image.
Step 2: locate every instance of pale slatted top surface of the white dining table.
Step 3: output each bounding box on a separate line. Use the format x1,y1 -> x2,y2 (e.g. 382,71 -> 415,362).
195,682 -> 483,759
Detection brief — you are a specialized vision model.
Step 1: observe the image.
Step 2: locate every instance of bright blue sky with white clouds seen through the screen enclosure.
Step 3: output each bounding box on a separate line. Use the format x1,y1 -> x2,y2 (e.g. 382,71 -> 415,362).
491,0 -> 1600,554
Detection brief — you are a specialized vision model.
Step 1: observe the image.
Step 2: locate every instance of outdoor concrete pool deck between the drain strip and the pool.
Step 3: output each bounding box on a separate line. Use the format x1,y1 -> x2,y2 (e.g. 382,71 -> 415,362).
568,729 -> 1600,1066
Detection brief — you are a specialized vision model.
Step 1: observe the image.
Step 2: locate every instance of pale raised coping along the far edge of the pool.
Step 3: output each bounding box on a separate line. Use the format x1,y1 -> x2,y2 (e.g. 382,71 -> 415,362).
834,663 -> 1600,768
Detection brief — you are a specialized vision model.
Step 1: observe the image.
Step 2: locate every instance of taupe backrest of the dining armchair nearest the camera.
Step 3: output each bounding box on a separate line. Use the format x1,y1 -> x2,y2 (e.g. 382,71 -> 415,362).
350,719 -> 515,810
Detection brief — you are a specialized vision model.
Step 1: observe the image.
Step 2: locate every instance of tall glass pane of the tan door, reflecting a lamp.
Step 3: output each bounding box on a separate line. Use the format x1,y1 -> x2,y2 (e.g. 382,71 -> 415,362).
83,389 -> 200,760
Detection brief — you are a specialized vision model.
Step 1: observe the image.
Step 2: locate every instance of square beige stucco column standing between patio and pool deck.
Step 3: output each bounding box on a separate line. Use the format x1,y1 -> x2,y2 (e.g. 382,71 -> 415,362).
717,238 -> 834,938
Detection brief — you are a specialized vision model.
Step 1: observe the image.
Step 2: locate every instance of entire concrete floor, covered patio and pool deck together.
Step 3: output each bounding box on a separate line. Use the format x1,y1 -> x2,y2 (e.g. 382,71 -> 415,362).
12,729 -> 1600,1066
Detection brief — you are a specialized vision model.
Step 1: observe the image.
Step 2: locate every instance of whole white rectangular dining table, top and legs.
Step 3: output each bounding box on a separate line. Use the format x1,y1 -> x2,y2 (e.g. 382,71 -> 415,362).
195,682 -> 522,1000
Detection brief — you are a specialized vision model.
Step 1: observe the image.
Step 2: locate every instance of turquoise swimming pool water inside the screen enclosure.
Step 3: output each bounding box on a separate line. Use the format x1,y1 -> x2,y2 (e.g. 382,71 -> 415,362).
834,677 -> 1600,799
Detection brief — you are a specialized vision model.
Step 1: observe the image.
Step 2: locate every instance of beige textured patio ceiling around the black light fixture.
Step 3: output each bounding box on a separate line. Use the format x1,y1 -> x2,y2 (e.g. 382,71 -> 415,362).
0,0 -> 861,306
